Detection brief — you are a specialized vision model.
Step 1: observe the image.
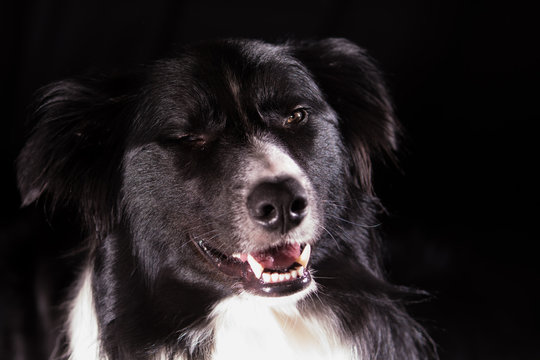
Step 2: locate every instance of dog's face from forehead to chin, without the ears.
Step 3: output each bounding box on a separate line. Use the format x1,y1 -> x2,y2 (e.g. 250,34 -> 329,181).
121,40 -> 345,296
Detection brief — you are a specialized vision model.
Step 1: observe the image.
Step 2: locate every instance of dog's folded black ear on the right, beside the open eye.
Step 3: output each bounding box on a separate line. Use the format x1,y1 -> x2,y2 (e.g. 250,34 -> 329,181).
291,39 -> 399,192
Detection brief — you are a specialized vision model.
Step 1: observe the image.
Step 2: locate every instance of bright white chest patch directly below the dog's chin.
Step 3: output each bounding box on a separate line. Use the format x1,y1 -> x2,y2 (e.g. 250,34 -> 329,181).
207,299 -> 356,360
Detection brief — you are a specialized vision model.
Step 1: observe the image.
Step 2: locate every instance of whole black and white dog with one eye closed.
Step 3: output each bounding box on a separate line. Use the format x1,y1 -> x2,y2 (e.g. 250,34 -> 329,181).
18,39 -> 432,360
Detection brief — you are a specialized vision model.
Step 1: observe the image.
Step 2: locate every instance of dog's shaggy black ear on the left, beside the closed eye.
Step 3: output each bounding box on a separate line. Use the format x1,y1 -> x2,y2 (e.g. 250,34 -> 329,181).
17,79 -> 133,231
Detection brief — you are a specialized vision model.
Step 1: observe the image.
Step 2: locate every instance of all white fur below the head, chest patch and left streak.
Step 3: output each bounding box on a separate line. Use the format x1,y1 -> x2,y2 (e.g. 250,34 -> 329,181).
68,270 -> 359,360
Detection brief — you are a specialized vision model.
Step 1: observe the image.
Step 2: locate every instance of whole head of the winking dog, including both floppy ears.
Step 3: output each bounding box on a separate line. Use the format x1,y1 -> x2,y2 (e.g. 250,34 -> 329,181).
18,39 -> 397,296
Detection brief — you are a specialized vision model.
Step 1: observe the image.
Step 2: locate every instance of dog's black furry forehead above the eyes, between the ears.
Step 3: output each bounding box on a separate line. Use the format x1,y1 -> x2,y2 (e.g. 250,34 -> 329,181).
149,41 -> 323,131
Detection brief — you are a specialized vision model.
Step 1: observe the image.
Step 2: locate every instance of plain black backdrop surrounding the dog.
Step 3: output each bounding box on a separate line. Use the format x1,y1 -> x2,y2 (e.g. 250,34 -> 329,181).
0,0 -> 540,359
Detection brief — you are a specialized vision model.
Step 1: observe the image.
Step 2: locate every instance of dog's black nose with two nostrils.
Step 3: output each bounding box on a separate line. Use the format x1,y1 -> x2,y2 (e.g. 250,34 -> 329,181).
247,177 -> 308,234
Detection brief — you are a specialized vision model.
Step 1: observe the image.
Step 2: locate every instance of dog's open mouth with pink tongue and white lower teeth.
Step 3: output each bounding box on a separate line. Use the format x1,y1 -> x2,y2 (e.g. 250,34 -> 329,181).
193,236 -> 311,297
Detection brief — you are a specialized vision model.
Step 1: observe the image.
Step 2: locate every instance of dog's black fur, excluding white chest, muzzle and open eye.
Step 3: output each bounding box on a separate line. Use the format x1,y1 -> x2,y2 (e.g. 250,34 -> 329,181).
18,39 -> 433,359
